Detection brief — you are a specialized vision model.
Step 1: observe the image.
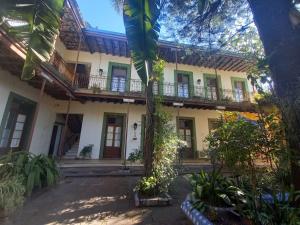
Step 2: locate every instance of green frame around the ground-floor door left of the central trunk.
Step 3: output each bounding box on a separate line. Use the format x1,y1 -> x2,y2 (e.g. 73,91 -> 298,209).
99,112 -> 127,160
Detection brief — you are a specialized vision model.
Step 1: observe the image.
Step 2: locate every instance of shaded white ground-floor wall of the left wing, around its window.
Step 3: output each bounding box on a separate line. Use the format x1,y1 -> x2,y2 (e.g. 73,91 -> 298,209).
0,69 -> 55,154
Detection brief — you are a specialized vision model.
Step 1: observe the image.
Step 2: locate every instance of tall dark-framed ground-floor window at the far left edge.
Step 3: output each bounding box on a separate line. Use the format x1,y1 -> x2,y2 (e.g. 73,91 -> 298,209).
0,93 -> 36,153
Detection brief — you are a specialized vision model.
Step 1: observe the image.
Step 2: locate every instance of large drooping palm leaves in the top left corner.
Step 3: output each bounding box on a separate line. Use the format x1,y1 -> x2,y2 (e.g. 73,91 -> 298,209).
0,0 -> 64,80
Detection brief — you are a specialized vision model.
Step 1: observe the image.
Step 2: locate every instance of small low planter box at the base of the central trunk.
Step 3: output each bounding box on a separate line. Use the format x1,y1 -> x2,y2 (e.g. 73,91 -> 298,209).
134,192 -> 172,207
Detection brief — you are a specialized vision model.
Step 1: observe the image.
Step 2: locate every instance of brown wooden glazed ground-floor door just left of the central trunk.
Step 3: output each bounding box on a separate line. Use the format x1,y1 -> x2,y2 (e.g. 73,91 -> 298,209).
103,116 -> 123,159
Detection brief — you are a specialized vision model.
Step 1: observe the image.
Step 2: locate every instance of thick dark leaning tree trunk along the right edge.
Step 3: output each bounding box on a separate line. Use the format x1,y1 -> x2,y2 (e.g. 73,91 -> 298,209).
248,0 -> 300,190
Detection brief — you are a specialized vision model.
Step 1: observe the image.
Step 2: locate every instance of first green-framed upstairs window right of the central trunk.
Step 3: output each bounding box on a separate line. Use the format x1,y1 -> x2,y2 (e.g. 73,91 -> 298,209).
174,70 -> 194,98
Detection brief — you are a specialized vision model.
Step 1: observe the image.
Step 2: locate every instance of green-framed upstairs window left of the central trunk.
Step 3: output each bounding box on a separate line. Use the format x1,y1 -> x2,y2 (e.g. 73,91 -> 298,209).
107,62 -> 131,92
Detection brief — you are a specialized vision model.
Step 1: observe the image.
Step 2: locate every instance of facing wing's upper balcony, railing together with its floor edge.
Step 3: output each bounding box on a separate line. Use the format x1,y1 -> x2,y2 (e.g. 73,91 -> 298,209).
74,75 -> 254,111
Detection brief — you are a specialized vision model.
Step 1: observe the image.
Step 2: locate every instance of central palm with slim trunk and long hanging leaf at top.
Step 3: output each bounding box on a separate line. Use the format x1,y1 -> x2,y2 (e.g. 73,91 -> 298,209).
123,0 -> 161,176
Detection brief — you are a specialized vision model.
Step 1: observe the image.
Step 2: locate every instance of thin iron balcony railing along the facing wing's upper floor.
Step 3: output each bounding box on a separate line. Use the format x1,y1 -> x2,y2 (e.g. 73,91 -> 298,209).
75,75 -> 251,103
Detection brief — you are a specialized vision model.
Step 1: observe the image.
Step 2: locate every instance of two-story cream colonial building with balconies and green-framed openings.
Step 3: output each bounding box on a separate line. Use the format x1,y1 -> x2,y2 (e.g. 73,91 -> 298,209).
0,0 -> 254,162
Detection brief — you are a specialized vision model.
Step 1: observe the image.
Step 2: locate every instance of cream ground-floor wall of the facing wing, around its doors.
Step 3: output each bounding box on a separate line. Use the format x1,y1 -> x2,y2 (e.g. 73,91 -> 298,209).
55,101 -> 219,159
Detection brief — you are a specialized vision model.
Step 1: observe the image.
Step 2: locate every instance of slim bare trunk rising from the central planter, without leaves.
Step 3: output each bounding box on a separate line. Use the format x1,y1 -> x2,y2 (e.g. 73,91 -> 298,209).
144,80 -> 155,177
